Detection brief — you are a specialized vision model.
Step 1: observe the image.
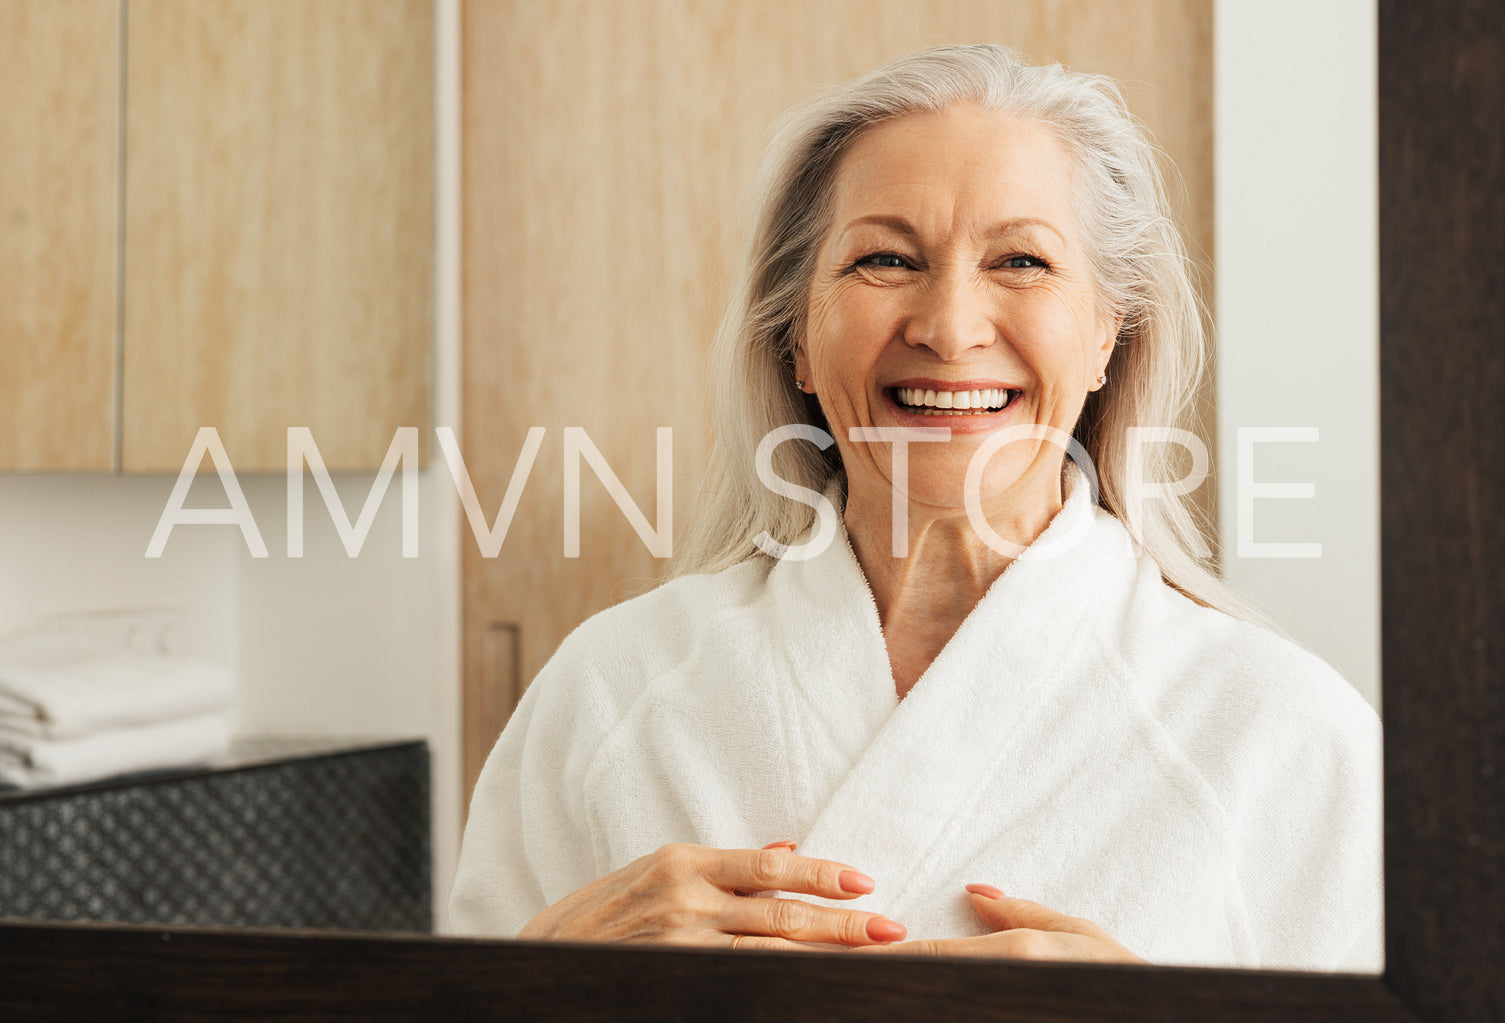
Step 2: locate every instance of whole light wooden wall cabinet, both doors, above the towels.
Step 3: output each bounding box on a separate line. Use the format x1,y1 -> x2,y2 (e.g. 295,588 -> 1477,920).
0,0 -> 433,472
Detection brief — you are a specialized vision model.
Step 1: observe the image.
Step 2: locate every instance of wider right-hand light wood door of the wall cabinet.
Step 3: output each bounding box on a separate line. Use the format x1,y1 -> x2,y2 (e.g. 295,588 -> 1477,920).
122,0 -> 433,471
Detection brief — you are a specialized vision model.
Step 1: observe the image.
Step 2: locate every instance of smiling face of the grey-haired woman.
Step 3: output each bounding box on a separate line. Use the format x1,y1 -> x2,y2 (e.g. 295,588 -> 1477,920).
796,105 -> 1118,526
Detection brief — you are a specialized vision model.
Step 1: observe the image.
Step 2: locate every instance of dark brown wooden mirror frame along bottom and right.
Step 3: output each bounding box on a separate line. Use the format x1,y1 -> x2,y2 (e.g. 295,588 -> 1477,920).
0,0 -> 1505,1021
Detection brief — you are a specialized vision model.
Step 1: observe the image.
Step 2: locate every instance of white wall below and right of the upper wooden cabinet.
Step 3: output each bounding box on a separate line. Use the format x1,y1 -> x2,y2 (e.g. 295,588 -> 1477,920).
0,0 -> 461,928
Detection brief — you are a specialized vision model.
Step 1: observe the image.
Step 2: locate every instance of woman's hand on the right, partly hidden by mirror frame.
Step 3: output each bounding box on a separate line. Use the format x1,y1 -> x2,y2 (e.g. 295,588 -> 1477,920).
859,885 -> 1150,963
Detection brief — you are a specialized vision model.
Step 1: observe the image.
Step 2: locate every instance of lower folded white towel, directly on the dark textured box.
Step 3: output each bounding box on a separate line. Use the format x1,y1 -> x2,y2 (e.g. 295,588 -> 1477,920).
0,712 -> 232,788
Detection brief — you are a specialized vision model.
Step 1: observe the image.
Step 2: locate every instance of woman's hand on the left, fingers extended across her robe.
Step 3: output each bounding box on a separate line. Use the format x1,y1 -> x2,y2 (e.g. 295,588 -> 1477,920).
518,842 -> 905,949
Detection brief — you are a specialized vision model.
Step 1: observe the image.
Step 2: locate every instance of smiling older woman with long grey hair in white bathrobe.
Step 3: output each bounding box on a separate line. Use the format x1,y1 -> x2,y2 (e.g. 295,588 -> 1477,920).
453,47 -> 1380,970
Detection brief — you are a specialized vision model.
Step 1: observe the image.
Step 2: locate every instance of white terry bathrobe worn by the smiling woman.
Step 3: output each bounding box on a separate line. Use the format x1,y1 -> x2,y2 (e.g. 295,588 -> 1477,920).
450,475 -> 1383,972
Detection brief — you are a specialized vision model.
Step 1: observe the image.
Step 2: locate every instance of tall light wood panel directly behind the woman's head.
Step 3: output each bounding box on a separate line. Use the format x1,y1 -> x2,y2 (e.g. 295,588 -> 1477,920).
462,0 -> 1213,785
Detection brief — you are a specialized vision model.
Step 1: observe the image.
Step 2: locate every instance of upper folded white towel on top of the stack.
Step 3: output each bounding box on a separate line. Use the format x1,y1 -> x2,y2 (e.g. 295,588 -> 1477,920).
0,635 -> 235,739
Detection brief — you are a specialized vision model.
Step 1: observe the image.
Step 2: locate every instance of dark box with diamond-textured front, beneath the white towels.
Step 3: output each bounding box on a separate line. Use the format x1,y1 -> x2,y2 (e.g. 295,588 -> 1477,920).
0,742 -> 432,931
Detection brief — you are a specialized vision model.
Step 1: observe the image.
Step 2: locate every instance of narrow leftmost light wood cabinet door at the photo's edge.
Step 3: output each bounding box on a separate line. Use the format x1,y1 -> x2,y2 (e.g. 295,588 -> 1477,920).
0,0 -> 120,469
